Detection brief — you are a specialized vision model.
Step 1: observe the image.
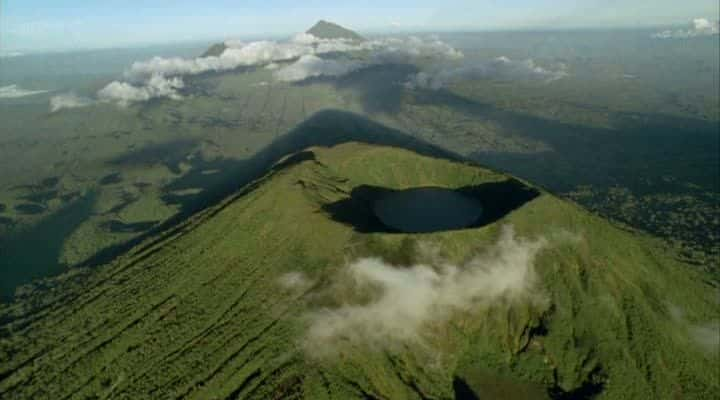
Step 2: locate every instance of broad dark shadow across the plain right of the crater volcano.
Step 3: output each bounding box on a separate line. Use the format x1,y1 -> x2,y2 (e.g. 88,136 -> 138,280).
412,90 -> 720,193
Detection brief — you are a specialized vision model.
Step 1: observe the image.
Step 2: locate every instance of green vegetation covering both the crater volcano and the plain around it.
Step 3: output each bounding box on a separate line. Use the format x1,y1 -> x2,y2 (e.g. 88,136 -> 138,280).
0,28 -> 720,399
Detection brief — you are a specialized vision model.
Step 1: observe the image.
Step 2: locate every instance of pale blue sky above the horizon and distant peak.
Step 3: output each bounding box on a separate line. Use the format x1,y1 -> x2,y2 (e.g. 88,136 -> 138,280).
0,0 -> 719,51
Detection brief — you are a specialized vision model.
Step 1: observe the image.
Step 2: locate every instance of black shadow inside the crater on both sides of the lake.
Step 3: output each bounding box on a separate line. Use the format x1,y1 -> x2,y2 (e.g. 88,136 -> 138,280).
323,178 -> 540,233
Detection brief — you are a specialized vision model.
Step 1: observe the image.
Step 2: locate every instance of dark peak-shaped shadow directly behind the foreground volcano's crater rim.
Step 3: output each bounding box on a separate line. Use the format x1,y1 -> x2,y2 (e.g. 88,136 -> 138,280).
76,110 -> 466,267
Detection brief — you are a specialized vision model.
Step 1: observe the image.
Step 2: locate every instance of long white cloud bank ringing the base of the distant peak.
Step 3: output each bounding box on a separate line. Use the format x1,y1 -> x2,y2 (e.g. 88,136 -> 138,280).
83,33 -> 462,106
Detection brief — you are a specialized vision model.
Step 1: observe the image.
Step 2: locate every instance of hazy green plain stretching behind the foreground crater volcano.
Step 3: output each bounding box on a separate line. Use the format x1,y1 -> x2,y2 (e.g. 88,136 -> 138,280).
0,32 -> 720,298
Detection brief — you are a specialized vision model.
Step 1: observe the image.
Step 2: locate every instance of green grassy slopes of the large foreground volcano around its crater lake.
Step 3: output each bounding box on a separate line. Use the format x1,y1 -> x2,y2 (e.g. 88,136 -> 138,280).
0,143 -> 720,399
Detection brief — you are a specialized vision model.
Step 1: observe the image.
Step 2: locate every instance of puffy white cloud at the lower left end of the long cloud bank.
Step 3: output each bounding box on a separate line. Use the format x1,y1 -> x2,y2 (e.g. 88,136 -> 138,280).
98,74 -> 185,106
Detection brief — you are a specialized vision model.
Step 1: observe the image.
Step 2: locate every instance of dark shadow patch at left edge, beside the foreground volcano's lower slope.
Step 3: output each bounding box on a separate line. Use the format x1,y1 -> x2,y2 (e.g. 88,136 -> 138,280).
0,192 -> 97,301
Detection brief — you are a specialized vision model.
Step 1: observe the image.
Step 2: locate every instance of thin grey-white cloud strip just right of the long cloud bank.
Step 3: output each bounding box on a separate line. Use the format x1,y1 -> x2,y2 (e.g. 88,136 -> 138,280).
405,57 -> 568,90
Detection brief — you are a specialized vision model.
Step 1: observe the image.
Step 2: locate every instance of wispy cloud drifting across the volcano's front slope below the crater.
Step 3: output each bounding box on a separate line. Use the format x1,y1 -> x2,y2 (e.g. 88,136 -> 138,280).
306,226 -> 548,355
